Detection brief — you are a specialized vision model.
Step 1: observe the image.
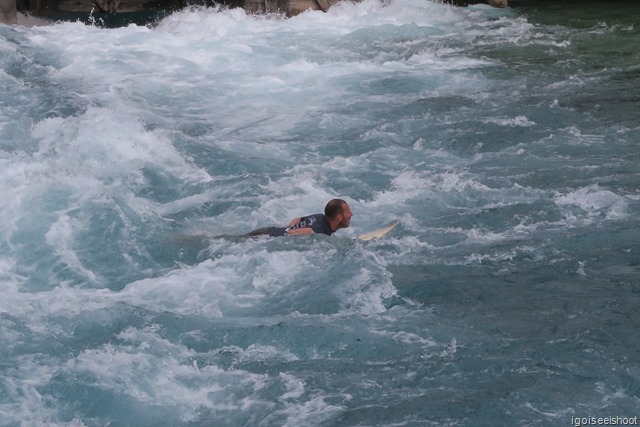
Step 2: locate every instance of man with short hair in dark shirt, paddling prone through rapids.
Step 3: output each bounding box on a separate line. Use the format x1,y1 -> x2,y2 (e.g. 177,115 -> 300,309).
247,199 -> 353,237
